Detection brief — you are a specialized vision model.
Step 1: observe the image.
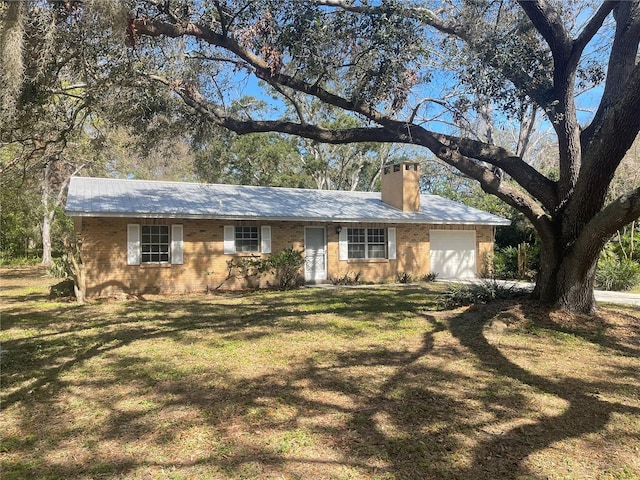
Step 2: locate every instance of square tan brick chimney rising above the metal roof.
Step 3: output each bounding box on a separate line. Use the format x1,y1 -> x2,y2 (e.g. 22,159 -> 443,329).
382,162 -> 420,212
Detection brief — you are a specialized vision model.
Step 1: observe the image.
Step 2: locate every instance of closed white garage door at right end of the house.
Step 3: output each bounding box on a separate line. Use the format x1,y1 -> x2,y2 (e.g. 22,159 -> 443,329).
429,230 -> 476,278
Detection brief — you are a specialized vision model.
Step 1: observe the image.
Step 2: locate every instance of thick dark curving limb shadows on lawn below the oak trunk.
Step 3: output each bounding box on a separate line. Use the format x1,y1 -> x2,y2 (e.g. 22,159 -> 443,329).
450,301 -> 640,478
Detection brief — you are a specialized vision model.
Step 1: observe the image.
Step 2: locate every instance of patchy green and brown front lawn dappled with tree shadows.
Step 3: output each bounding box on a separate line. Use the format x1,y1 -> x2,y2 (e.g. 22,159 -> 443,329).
0,267 -> 640,480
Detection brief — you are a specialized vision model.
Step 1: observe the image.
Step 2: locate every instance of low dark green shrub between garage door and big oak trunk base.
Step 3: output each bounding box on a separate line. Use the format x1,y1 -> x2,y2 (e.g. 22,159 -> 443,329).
438,278 -> 526,309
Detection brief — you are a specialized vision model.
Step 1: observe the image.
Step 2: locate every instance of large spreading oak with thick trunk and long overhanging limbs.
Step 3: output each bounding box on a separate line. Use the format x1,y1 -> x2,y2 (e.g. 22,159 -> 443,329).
5,0 -> 640,312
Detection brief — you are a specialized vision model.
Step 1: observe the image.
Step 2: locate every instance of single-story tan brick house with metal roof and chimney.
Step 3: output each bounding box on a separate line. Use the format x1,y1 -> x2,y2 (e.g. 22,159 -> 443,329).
66,162 -> 509,297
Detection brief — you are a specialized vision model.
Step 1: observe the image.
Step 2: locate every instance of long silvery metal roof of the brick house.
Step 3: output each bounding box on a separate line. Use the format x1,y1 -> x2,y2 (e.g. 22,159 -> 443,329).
66,177 -> 510,225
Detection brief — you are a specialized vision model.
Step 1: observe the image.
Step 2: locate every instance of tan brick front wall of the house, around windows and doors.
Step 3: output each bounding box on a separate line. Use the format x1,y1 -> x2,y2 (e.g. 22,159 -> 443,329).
75,217 -> 493,297
